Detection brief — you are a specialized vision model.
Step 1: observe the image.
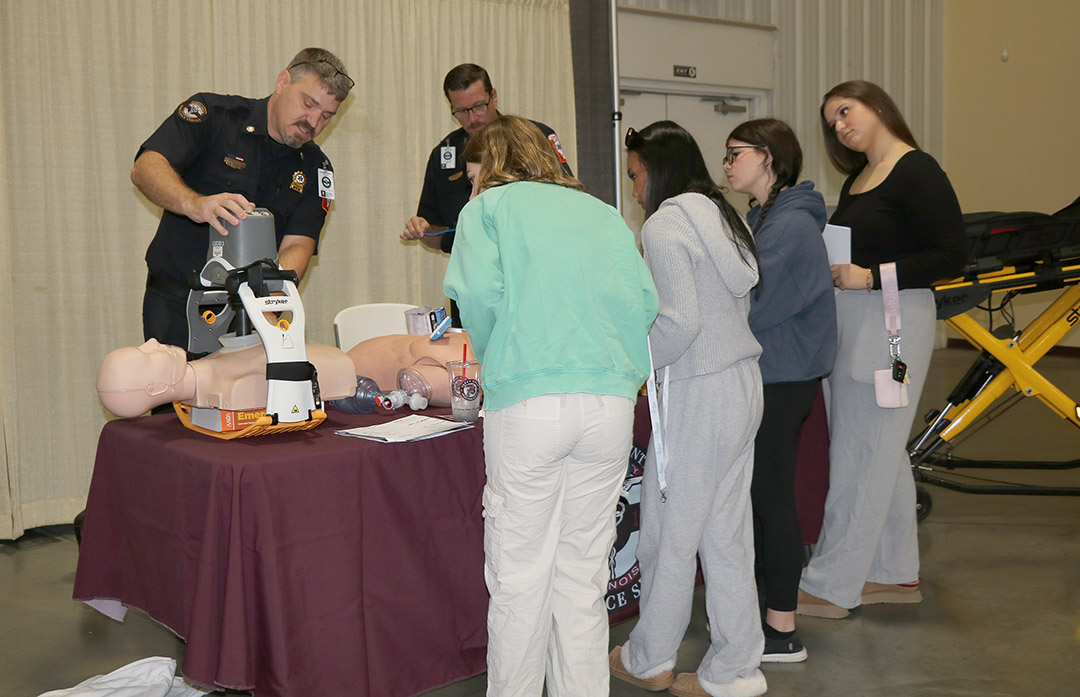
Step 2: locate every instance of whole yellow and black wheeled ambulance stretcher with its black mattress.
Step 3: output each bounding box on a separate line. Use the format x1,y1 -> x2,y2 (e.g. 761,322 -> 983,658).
907,206 -> 1080,520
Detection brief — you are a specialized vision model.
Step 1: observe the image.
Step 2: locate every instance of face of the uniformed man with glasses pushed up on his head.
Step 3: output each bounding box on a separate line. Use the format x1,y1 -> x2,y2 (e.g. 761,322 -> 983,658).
267,70 -> 341,148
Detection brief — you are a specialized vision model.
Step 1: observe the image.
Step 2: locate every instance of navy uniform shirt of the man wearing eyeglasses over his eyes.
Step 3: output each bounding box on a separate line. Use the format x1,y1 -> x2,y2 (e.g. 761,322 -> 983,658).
416,121 -> 572,253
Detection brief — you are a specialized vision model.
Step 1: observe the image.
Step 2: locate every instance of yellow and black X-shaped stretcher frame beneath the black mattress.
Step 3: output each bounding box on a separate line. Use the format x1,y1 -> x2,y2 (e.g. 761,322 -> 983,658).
908,259 -> 1080,503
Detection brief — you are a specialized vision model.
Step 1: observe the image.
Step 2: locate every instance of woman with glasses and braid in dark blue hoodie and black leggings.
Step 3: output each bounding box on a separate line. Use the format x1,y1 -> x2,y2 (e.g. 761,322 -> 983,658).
724,119 -> 836,664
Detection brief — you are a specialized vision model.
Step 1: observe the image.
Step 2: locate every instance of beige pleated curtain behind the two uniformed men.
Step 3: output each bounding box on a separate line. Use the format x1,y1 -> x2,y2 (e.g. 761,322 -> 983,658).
0,0 -> 576,539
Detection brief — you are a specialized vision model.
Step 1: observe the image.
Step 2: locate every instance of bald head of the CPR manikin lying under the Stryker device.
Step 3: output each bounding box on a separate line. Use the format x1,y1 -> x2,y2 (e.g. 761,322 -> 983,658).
97,339 -> 195,418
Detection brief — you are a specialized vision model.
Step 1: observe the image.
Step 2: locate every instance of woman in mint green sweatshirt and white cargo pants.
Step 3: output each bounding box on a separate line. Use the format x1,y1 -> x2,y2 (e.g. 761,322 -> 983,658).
444,116 -> 658,697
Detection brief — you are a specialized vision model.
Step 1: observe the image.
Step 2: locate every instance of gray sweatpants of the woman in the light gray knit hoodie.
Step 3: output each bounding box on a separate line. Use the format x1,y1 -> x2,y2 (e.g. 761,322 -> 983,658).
622,359 -> 766,697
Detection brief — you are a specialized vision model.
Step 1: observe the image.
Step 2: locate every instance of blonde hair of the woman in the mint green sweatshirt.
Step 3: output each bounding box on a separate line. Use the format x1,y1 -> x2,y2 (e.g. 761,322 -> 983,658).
464,115 -> 585,191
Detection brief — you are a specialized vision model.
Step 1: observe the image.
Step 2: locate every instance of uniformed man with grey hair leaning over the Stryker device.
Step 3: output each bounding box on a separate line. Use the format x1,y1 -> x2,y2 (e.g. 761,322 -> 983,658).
132,48 -> 354,356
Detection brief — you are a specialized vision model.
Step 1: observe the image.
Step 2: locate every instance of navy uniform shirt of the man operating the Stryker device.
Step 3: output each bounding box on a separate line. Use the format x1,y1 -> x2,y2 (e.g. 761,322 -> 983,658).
141,93 -> 333,284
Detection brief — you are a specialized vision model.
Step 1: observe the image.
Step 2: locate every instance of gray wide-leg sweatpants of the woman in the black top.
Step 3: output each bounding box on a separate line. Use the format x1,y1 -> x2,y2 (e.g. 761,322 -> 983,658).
799,289 -> 935,608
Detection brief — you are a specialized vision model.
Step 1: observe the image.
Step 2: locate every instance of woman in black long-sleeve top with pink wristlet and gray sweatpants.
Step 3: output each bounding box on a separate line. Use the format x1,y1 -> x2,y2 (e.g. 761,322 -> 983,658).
797,81 -> 966,618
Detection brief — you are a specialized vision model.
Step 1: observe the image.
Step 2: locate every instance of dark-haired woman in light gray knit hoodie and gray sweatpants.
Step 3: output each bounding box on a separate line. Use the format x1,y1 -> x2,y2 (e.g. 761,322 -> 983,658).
609,121 -> 766,697
